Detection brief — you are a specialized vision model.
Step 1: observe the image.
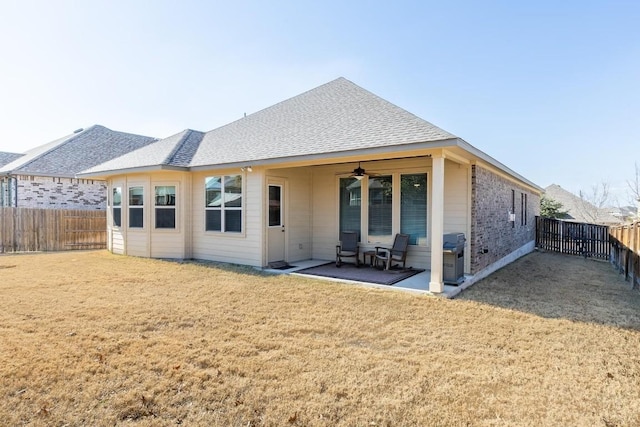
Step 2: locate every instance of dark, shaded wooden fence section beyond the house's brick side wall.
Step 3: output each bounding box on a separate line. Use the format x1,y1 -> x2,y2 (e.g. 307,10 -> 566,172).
536,217 -> 611,260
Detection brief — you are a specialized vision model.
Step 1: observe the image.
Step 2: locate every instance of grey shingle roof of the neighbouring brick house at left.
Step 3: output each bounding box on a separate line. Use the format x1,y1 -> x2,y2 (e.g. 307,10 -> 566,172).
0,125 -> 157,177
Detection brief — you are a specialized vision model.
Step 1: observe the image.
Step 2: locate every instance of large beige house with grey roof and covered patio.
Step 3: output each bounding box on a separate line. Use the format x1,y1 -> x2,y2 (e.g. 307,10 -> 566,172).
79,78 -> 542,292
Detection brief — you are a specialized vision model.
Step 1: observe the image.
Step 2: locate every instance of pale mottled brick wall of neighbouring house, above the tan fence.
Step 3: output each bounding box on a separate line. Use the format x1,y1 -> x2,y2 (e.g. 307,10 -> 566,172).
17,175 -> 107,210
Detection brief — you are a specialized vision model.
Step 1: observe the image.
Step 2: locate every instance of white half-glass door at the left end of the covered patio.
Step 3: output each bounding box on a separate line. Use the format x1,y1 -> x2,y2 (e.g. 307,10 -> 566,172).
267,178 -> 287,263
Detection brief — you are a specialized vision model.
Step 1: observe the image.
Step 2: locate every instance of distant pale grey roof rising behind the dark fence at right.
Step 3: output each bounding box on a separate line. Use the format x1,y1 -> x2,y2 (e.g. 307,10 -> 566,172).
544,184 -> 623,225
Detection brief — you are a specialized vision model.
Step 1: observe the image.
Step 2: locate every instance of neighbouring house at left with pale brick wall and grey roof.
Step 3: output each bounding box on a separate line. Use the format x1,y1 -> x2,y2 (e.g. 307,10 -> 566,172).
0,125 -> 157,209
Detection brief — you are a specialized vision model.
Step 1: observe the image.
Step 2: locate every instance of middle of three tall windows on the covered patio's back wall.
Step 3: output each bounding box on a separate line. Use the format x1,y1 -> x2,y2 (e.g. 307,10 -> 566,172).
368,175 -> 393,243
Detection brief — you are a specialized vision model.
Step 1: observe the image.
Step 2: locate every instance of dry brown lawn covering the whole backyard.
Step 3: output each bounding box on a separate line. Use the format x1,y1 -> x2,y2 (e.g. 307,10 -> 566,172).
0,251 -> 640,426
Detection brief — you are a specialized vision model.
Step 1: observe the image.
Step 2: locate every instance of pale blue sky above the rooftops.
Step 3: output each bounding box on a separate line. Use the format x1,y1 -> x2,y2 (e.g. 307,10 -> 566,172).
0,0 -> 640,204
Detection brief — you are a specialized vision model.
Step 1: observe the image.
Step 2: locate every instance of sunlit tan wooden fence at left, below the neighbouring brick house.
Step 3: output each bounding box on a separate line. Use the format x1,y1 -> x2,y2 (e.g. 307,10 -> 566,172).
0,208 -> 107,253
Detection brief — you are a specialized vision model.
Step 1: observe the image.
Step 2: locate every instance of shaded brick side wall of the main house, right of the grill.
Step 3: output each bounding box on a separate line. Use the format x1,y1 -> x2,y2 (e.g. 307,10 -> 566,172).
469,165 -> 540,274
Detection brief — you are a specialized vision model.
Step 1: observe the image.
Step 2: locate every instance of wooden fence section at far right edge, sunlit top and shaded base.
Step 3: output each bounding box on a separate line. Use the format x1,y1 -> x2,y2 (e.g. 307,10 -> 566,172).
610,221 -> 640,289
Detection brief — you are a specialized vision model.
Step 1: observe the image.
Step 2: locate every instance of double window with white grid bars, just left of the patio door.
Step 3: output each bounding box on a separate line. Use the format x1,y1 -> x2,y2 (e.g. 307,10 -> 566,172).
205,175 -> 242,233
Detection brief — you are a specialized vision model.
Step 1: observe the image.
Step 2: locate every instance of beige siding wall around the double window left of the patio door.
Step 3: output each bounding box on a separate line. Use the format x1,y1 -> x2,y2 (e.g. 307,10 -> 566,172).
191,168 -> 265,267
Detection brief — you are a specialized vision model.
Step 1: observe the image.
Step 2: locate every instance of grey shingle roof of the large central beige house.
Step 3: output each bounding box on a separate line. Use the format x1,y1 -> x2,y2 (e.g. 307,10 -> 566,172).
83,78 -> 456,174
